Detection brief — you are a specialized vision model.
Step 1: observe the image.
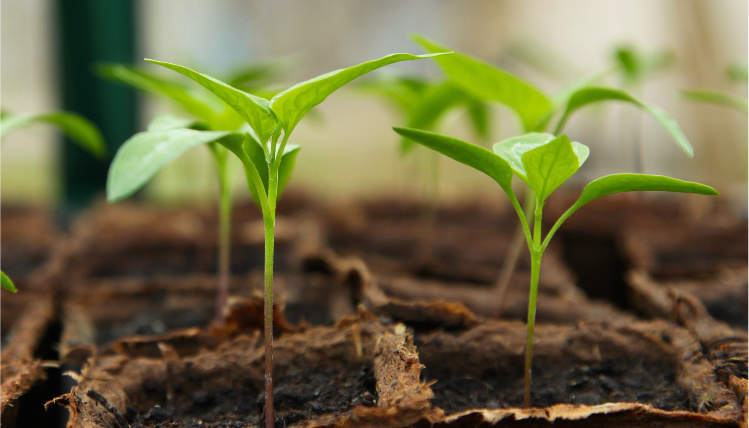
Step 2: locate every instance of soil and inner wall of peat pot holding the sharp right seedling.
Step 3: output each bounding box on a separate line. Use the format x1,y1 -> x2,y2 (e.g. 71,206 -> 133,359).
416,323 -> 739,420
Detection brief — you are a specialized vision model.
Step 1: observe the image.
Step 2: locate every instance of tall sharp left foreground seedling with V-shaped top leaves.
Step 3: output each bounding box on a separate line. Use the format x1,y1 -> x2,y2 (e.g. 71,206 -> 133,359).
107,54 -> 442,428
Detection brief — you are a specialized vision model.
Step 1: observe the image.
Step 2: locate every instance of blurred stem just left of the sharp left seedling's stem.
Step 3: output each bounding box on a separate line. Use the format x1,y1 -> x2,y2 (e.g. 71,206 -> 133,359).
216,163 -> 232,325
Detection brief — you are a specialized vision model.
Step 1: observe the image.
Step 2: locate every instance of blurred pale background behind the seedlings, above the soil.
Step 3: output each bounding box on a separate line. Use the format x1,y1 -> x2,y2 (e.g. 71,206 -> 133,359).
0,0 -> 748,212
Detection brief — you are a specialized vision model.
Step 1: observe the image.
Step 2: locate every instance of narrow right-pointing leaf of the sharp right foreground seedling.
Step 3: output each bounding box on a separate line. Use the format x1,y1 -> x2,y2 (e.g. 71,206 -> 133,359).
571,174 -> 718,211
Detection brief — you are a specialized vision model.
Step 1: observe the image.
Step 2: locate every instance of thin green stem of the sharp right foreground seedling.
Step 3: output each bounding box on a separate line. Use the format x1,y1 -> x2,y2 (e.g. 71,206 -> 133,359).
523,198 -> 544,407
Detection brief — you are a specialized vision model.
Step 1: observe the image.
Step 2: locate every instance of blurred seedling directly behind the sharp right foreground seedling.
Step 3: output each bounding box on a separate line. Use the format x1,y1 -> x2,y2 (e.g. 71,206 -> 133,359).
414,35 -> 694,317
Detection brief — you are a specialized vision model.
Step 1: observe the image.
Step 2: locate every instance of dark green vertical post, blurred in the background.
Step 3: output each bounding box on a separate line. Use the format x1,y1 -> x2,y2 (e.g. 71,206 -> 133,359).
56,0 -> 137,211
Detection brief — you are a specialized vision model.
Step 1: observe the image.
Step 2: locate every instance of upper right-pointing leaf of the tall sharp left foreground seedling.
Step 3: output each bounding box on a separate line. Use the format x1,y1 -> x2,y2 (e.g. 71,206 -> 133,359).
270,53 -> 442,134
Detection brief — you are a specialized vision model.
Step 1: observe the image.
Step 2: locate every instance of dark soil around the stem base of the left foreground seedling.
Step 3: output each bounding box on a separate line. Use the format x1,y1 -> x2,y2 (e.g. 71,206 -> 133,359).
126,364 -> 376,428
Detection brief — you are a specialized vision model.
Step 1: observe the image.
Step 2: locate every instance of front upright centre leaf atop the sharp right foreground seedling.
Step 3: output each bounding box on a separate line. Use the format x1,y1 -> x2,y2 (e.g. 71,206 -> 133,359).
522,135 -> 587,202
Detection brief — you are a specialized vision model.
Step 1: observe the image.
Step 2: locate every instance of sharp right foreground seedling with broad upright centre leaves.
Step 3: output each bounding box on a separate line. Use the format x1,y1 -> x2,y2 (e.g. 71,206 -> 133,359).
394,128 -> 718,407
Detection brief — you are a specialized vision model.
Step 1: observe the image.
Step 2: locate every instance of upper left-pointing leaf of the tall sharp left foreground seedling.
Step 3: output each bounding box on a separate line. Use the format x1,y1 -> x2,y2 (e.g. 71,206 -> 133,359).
146,59 -> 277,142
